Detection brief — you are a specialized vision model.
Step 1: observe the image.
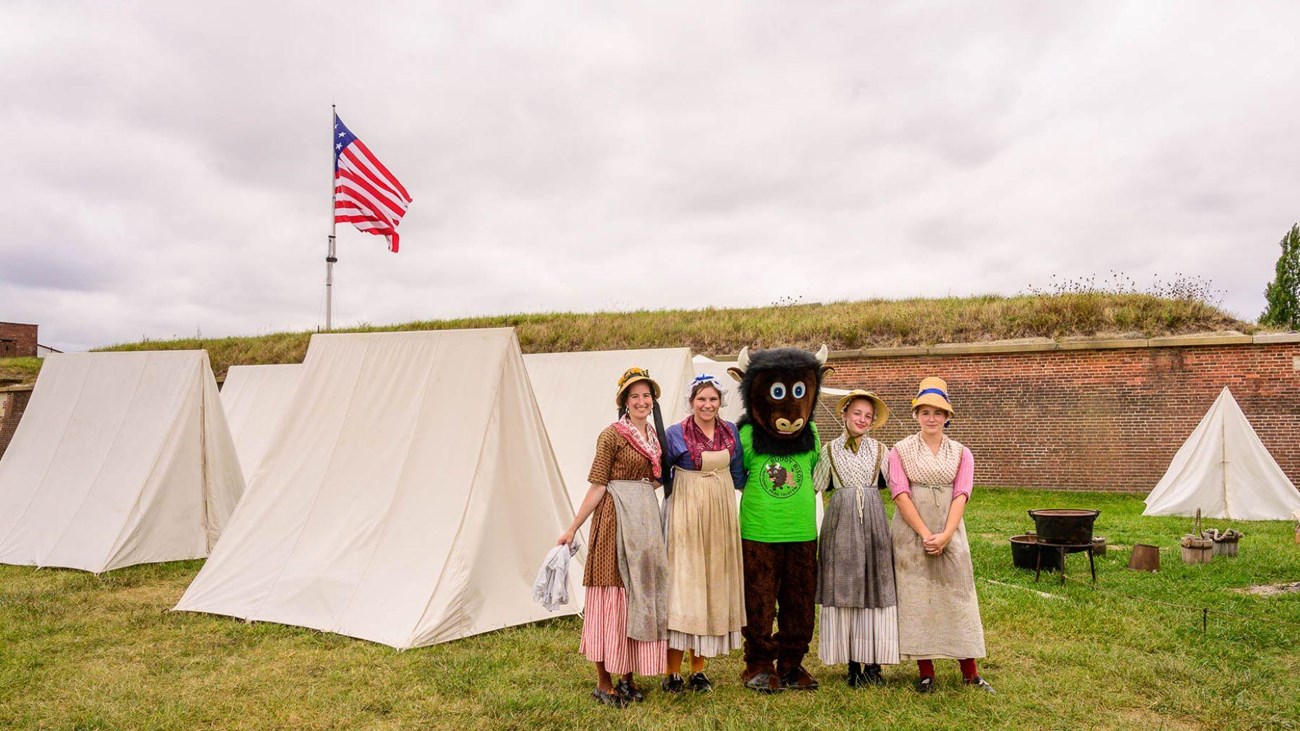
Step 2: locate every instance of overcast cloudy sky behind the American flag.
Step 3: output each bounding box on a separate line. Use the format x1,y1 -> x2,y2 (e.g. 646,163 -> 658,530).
0,0 -> 1300,350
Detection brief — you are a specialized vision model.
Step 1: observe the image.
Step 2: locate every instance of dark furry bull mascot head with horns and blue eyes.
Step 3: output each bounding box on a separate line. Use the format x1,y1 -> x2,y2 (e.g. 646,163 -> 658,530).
727,345 -> 832,455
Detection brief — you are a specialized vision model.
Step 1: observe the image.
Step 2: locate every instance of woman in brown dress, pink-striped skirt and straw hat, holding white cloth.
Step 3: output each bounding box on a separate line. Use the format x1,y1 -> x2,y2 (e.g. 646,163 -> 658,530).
556,368 -> 668,708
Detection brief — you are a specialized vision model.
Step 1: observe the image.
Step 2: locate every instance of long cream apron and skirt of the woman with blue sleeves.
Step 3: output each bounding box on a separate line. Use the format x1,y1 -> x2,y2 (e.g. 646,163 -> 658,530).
667,453 -> 745,657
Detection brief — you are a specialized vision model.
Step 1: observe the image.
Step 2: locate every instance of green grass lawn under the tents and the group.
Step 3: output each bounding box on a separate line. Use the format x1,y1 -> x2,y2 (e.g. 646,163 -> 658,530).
0,489 -> 1300,730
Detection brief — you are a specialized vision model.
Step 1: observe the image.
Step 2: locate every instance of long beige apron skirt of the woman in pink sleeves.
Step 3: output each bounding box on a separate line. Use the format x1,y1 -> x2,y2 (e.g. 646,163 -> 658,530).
893,484 -> 984,659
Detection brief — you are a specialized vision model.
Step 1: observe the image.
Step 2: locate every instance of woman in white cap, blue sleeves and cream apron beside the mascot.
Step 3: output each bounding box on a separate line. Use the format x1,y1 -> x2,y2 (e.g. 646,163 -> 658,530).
663,375 -> 745,693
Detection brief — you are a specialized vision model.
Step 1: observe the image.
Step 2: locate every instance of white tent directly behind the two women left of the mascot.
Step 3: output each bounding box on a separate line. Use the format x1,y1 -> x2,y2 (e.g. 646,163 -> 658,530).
524,347 -> 696,510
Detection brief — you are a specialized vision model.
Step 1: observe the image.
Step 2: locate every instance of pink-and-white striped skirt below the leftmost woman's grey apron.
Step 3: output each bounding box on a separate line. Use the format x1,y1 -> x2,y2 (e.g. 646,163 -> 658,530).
579,587 -> 668,675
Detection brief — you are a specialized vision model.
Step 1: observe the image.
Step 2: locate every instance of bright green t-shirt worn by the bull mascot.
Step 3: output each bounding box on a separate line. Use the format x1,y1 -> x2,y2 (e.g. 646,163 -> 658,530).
740,424 -> 822,544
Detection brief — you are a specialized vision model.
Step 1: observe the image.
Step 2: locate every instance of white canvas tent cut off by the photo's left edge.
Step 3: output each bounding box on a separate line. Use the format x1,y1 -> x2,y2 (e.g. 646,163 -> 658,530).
0,350 -> 243,574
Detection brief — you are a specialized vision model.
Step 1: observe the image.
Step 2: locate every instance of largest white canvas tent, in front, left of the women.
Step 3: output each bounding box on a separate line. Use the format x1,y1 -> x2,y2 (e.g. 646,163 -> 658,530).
176,329 -> 573,648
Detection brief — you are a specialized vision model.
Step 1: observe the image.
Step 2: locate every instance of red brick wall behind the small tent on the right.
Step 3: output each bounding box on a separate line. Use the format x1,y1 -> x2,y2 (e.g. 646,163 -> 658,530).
818,343 -> 1300,492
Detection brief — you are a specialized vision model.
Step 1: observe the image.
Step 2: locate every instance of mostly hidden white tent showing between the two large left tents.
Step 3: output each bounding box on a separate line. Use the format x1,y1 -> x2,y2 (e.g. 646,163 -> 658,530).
221,363 -> 303,481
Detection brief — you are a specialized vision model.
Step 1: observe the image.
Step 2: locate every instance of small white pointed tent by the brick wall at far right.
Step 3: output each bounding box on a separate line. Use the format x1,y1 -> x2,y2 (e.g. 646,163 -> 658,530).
1143,388 -> 1300,520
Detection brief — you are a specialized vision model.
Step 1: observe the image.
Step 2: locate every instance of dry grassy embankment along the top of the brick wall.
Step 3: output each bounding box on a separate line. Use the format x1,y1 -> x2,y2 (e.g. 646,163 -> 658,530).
0,291 -> 1260,377
